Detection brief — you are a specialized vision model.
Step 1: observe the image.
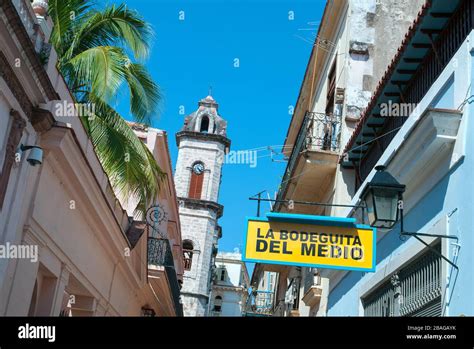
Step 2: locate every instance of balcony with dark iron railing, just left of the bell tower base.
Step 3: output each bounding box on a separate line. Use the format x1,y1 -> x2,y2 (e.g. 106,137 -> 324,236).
148,236 -> 183,316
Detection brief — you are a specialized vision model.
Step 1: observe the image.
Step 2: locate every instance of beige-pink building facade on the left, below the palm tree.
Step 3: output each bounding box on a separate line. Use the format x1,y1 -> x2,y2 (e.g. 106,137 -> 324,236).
0,0 -> 180,316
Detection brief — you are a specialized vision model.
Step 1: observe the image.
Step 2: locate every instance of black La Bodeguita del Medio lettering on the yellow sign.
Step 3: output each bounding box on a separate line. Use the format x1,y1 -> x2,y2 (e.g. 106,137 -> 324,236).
255,228 -> 364,261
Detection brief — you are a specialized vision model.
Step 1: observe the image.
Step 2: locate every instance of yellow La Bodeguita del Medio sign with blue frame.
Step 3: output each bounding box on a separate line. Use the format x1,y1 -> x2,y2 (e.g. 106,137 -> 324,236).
244,213 -> 376,271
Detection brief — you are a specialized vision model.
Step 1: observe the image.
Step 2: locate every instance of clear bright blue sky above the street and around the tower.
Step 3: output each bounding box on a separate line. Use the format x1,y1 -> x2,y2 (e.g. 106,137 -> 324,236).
108,0 -> 325,266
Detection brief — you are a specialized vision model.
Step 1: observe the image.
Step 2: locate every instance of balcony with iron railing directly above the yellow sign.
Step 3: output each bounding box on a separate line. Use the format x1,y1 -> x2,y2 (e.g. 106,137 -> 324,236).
275,112 -> 341,214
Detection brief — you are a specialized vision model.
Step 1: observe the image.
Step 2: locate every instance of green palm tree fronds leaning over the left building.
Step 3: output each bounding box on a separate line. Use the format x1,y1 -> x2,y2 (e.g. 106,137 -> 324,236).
49,0 -> 164,215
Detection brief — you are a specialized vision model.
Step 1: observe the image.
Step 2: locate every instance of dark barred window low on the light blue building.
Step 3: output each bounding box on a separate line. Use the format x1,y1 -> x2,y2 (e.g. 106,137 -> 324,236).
362,244 -> 442,316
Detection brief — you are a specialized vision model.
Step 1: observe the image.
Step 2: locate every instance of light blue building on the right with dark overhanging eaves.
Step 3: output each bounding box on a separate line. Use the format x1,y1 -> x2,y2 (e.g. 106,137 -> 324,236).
330,0 -> 474,316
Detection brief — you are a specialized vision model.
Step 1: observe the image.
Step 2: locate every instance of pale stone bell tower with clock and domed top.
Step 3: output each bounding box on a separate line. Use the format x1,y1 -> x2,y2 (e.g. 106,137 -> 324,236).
174,96 -> 230,316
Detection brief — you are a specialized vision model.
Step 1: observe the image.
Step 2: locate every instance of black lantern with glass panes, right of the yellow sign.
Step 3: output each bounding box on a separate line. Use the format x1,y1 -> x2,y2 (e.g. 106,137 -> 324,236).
361,166 -> 405,229
